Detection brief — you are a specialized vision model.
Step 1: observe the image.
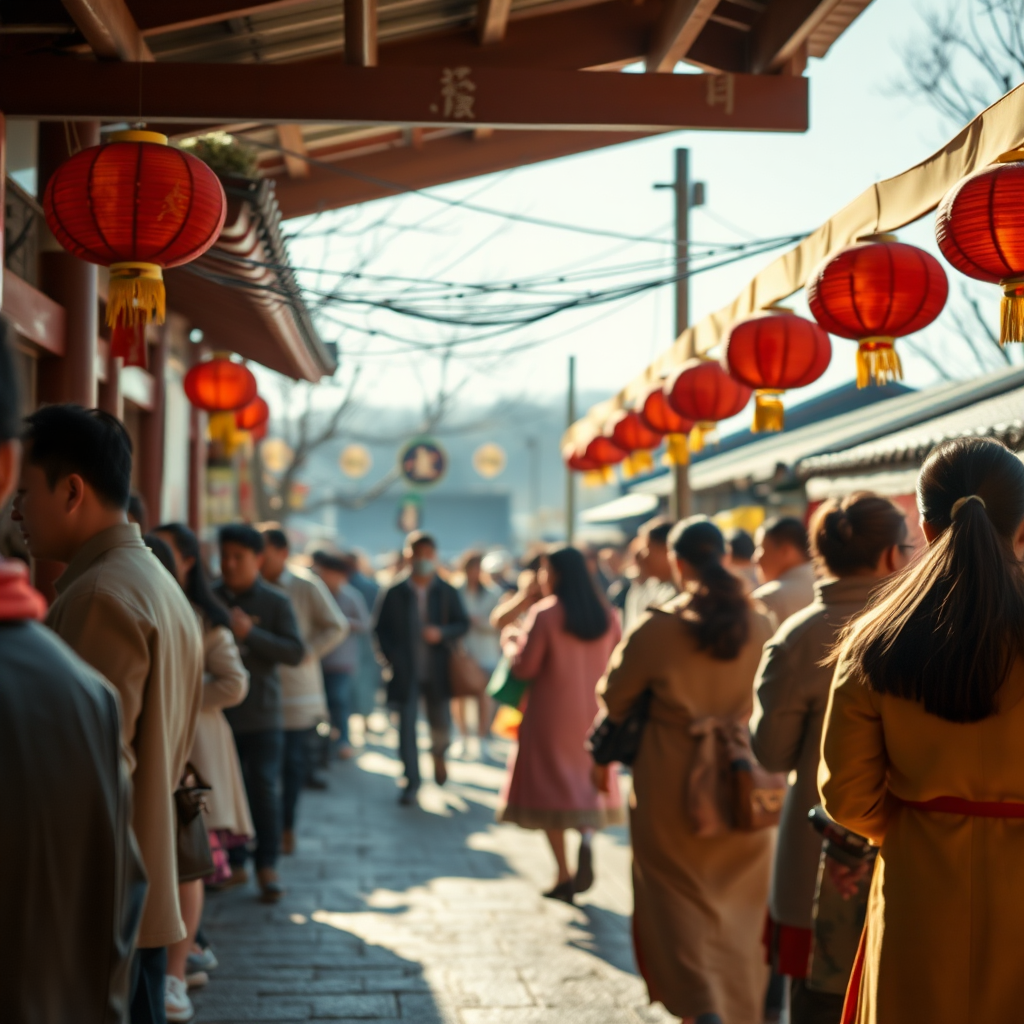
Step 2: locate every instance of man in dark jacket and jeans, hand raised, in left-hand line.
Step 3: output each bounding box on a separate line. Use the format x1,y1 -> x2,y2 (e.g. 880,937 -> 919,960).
214,523 -> 305,903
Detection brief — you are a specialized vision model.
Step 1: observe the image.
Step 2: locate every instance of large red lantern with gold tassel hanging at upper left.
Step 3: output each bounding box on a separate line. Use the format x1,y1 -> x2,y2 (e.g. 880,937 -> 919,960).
43,131 -> 227,366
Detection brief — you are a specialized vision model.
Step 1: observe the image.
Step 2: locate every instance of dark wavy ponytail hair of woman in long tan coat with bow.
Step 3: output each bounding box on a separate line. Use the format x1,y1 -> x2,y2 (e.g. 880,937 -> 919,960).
669,515 -> 751,662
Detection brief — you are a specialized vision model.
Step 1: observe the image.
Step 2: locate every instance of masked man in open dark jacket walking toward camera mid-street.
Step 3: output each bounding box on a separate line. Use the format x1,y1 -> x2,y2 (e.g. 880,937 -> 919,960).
376,532 -> 469,806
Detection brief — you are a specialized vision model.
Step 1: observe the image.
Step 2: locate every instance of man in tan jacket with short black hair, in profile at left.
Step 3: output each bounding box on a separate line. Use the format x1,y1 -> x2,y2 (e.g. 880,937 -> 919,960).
14,406 -> 203,1024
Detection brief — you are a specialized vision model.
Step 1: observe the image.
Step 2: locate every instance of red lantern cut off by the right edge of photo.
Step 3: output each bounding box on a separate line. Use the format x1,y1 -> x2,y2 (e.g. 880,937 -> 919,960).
935,150 -> 1024,342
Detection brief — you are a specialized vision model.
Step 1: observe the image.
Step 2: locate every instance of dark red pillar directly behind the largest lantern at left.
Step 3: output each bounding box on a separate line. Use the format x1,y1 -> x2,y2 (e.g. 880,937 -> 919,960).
39,121 -> 99,409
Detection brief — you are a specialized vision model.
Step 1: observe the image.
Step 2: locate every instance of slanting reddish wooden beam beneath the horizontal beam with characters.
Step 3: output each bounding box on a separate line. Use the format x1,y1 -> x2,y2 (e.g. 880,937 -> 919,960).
276,131 -> 646,218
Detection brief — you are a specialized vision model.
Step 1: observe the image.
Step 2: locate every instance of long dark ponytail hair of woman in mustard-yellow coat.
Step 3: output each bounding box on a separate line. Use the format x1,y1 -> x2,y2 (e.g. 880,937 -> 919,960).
842,437 -> 1024,722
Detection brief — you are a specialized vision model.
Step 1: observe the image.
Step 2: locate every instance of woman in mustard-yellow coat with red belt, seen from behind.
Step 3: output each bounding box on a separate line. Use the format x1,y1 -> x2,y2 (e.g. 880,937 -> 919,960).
818,437 -> 1024,1024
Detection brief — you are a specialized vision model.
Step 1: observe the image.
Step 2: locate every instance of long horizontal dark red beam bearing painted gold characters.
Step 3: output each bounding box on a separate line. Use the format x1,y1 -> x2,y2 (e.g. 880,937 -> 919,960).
0,56 -> 807,132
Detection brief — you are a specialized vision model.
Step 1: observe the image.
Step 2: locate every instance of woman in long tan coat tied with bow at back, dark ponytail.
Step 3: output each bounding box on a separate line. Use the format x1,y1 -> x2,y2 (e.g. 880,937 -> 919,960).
595,516 -> 774,1024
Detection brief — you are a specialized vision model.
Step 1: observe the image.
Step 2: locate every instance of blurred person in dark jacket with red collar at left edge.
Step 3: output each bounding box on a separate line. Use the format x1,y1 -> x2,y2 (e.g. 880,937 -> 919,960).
0,321 -> 146,1024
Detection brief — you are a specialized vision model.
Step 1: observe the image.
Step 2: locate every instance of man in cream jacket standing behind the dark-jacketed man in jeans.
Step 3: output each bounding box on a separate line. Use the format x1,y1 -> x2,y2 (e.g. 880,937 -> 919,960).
260,525 -> 348,854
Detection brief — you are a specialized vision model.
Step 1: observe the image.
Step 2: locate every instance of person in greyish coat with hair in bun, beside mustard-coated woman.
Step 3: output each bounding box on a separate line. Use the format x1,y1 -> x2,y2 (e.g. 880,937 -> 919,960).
753,492 -> 912,1024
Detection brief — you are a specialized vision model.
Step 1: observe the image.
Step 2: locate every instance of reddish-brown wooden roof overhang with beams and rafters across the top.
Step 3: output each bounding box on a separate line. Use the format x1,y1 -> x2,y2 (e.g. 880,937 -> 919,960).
0,0 -> 869,218
